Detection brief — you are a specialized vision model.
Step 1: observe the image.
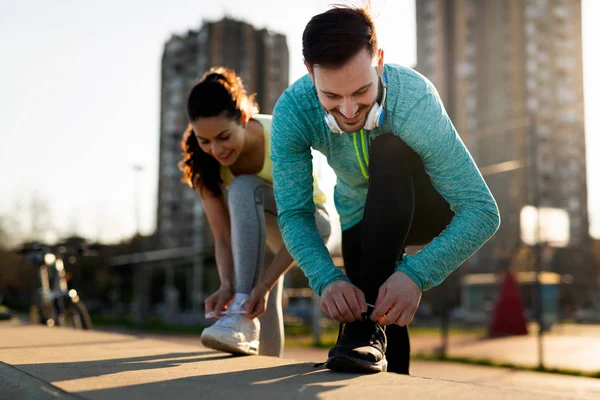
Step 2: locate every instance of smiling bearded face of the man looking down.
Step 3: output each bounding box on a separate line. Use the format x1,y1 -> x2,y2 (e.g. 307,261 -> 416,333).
307,49 -> 383,132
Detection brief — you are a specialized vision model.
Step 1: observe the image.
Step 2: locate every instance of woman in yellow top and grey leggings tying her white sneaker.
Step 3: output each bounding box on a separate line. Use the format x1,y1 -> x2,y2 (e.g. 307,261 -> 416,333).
180,68 -> 330,357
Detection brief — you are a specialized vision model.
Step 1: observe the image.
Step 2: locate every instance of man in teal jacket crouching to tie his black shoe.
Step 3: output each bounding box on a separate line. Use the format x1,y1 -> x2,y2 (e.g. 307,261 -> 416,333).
271,7 -> 500,374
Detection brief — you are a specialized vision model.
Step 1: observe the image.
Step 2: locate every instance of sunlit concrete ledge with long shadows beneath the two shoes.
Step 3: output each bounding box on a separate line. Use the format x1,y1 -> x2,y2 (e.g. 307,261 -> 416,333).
0,324 -> 569,400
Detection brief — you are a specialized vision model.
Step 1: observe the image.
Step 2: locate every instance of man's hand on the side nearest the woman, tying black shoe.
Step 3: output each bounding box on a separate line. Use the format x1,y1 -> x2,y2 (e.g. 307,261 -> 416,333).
321,280 -> 367,323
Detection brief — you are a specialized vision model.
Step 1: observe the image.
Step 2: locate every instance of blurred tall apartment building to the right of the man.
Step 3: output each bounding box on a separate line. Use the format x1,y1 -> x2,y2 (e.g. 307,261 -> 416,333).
416,0 -> 591,296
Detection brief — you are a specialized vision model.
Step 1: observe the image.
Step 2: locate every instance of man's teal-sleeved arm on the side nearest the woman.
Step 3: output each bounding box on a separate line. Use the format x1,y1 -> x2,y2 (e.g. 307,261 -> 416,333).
271,93 -> 348,295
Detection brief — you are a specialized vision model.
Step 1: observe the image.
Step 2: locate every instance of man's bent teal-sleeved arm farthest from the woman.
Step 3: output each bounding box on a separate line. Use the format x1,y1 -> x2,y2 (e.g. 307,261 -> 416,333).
393,87 -> 500,290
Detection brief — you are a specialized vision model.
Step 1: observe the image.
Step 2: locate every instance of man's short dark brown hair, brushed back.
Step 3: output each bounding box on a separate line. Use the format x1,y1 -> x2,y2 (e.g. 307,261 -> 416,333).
302,5 -> 378,68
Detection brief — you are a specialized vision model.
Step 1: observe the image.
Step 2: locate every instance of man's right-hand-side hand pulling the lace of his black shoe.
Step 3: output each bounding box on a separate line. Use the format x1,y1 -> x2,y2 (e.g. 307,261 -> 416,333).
371,271 -> 421,326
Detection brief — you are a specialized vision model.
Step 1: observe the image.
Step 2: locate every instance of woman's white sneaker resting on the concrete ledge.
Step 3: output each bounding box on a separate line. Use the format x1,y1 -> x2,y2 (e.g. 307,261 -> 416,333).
200,294 -> 260,355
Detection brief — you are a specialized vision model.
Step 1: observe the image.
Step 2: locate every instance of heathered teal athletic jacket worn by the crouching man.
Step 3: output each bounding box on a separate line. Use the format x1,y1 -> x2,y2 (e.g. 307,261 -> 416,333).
271,64 -> 500,295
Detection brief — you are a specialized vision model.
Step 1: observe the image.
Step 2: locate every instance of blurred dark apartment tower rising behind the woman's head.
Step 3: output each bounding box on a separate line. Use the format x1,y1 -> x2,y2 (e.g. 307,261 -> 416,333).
157,18 -> 289,252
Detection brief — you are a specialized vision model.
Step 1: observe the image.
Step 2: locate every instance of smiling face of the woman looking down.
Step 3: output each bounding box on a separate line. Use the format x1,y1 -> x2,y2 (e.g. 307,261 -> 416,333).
192,116 -> 245,167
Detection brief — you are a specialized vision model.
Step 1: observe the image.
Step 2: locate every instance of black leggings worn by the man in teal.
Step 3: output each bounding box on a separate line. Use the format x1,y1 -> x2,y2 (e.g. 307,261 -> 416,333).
342,134 -> 454,374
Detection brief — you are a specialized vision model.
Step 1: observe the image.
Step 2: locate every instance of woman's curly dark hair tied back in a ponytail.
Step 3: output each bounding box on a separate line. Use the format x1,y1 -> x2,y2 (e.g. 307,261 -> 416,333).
179,67 -> 258,196
